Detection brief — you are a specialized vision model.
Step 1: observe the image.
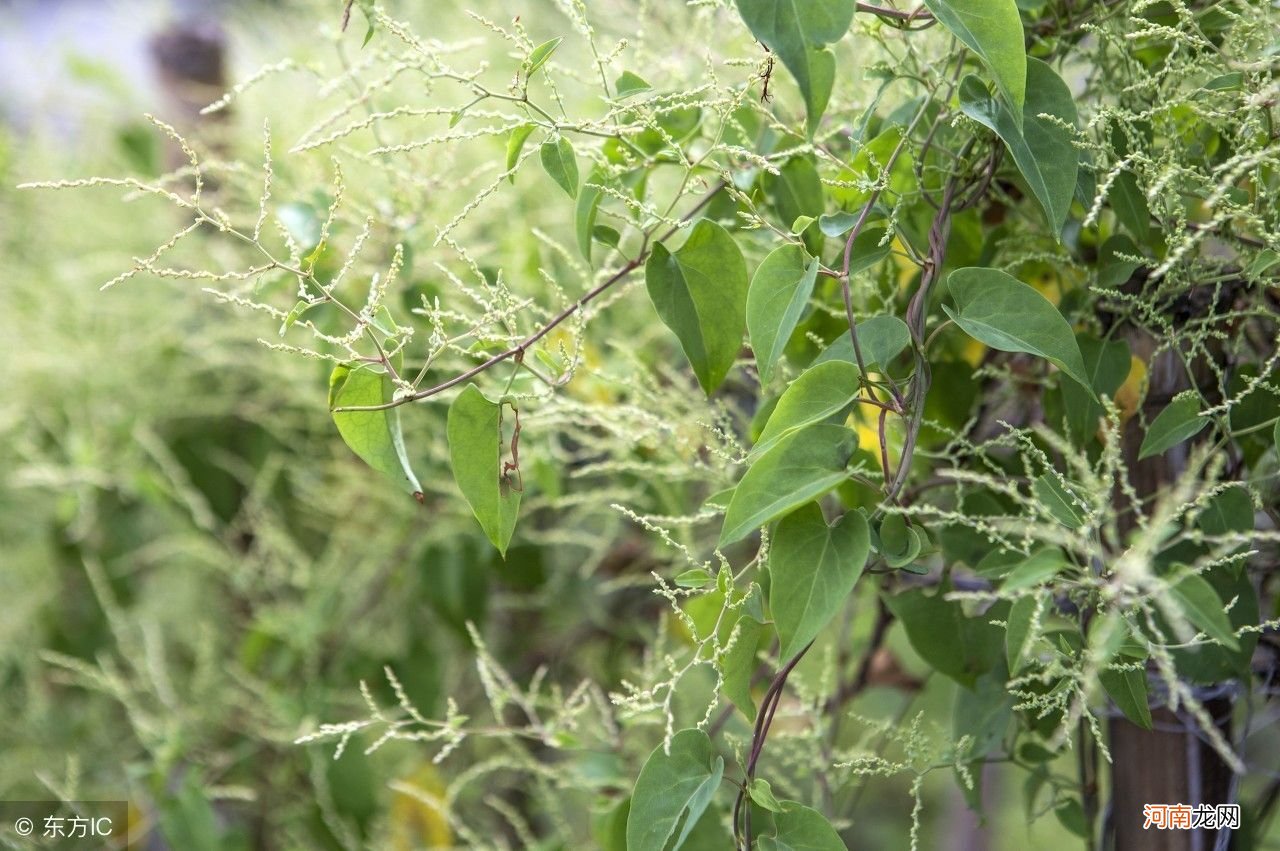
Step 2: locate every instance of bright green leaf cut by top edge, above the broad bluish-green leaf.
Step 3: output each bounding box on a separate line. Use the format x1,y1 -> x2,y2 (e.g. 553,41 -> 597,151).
924,0 -> 1024,117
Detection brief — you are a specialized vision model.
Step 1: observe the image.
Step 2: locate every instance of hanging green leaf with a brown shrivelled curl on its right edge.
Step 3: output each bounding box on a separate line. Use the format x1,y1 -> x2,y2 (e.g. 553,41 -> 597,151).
445,384 -> 521,558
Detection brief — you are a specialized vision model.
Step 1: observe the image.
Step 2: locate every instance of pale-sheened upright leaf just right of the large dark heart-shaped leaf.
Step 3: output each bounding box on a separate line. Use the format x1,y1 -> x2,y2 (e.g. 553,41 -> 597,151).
746,244 -> 819,384
